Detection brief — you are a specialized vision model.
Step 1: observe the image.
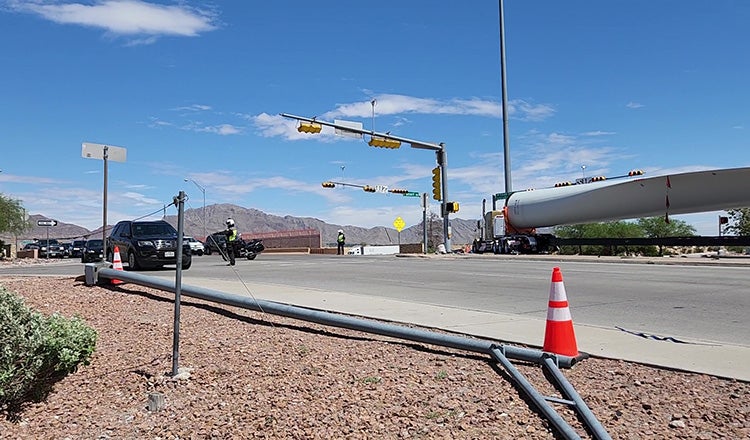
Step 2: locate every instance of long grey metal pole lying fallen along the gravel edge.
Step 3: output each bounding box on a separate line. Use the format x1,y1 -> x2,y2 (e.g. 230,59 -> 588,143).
97,268 -> 576,368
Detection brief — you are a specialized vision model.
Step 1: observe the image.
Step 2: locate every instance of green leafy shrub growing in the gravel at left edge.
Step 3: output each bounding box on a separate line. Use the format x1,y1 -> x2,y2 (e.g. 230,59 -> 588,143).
0,286 -> 97,420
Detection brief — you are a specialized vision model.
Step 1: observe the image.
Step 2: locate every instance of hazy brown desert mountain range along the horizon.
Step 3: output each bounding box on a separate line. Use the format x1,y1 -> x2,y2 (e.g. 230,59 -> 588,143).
0,203 -> 477,247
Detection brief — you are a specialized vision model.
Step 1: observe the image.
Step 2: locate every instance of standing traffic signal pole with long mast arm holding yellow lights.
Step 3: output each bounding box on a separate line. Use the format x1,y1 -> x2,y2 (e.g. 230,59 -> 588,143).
279,113 -> 451,252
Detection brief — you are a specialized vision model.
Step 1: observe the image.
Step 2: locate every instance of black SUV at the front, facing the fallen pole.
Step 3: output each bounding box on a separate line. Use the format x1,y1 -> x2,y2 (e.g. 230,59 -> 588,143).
107,220 -> 192,270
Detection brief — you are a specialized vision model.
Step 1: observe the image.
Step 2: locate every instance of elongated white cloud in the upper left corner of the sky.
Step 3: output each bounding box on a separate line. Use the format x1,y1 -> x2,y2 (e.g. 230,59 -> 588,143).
7,0 -> 217,40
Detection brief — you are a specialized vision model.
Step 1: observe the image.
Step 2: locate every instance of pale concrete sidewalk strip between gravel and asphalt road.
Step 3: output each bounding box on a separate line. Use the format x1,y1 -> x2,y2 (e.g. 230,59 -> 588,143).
173,278 -> 750,382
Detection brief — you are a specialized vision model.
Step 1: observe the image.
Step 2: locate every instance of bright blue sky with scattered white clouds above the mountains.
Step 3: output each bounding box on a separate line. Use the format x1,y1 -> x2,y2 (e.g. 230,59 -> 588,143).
0,0 -> 750,235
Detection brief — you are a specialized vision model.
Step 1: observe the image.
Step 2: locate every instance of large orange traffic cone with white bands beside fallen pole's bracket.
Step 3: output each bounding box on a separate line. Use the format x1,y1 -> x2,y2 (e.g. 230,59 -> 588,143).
543,267 -> 579,357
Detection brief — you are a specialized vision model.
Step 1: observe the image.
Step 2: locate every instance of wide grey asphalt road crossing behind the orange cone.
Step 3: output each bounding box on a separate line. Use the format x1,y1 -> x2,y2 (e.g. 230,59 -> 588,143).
0,254 -> 750,346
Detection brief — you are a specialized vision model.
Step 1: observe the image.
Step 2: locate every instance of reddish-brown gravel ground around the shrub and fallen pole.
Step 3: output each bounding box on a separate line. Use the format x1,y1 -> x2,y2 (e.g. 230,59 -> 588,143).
0,276 -> 750,440
